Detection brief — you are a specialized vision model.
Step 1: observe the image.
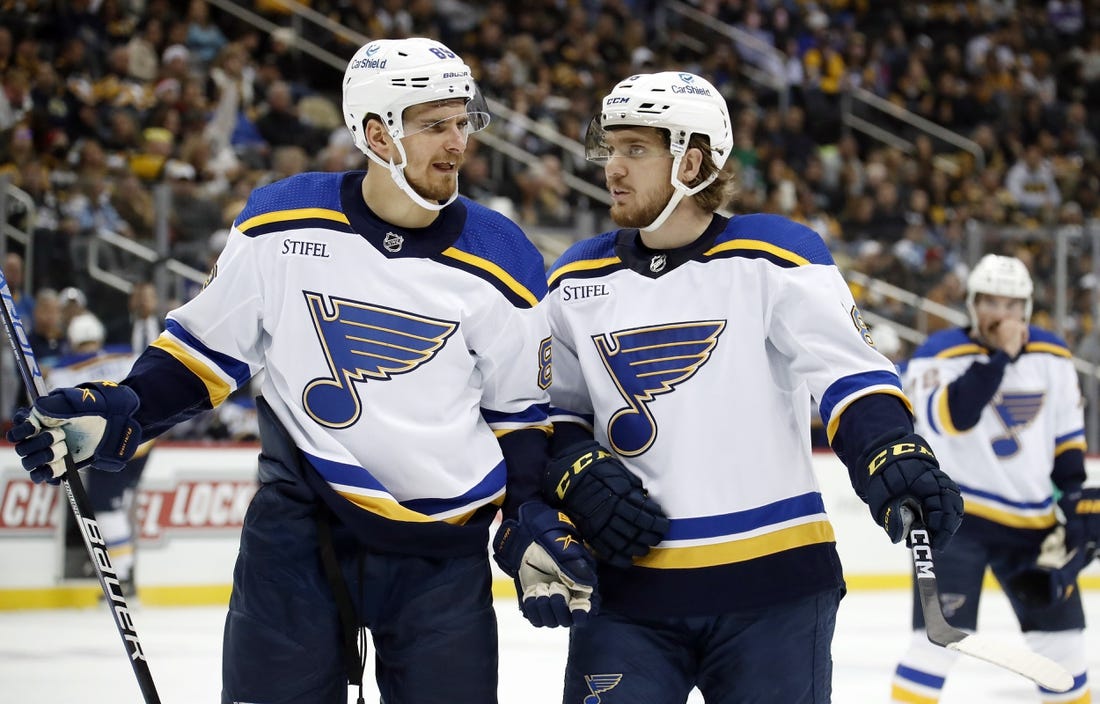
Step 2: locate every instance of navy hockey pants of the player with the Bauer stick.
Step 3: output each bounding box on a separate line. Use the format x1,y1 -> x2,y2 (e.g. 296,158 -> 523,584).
221,482 -> 497,704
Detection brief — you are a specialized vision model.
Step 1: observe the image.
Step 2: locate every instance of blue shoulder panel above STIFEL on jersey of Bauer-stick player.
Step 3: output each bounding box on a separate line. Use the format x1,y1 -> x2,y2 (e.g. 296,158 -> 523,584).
233,172 -> 351,237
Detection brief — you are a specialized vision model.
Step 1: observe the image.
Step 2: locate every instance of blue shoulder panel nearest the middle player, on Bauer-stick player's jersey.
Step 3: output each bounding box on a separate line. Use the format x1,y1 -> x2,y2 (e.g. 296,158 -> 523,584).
443,197 -> 547,306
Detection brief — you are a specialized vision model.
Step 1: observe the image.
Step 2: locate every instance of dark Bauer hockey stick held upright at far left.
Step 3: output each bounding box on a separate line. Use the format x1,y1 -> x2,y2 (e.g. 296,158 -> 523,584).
0,272 -> 161,704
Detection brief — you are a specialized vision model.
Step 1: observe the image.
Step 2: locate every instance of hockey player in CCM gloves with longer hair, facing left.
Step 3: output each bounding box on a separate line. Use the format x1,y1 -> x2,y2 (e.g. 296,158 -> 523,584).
543,72 -> 963,704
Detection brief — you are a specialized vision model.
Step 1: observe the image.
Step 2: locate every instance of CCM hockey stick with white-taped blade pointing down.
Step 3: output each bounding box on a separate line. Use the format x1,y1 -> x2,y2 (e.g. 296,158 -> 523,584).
901,505 -> 1074,692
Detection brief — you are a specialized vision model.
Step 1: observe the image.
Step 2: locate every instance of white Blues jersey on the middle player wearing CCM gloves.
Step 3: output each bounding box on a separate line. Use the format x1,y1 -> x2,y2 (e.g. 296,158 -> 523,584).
545,215 -> 908,614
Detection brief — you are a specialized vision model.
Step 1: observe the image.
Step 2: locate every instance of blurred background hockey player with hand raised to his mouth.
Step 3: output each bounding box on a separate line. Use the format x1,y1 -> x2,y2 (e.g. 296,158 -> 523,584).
891,254 -> 1100,704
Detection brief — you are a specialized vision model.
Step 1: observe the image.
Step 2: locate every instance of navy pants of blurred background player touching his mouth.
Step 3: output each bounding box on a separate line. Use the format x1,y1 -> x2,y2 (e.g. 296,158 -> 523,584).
913,529 -> 1085,633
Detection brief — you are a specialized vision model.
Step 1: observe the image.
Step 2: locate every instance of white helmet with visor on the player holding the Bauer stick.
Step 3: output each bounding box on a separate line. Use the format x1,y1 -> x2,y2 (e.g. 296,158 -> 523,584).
343,36 -> 490,210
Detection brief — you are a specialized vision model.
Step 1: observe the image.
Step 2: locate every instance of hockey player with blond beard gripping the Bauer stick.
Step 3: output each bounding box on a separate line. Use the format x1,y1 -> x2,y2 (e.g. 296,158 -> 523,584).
4,39 -> 595,704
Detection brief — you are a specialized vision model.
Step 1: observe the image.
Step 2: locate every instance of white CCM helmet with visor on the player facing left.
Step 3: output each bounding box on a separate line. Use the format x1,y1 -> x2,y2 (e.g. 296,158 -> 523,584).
584,70 -> 734,232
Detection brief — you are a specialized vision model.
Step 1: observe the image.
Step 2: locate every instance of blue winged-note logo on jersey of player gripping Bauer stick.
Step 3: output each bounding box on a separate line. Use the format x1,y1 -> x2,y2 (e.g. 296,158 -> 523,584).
301,292 -> 459,429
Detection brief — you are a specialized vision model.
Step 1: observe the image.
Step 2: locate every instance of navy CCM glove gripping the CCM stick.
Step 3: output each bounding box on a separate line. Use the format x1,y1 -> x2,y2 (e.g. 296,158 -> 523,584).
858,432 -> 963,550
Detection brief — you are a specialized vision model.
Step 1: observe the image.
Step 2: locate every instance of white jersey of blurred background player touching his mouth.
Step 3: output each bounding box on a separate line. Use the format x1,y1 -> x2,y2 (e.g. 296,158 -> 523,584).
904,326 -> 1085,530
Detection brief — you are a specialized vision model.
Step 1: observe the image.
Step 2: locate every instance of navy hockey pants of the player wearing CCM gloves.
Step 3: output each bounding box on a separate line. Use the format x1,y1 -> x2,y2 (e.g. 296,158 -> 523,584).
562,590 -> 843,704
